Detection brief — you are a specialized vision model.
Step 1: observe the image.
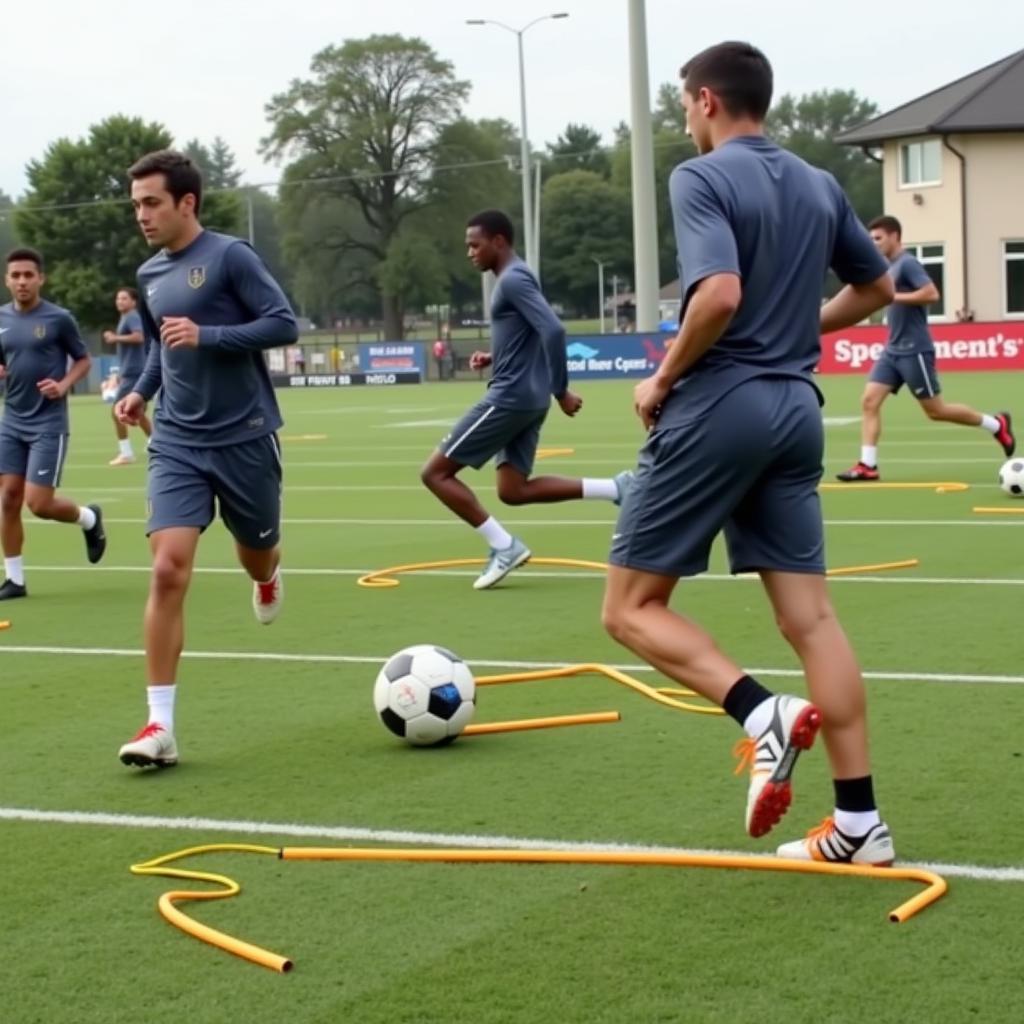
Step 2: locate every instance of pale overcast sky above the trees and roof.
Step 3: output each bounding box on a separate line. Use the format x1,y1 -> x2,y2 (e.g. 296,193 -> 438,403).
0,0 -> 1024,196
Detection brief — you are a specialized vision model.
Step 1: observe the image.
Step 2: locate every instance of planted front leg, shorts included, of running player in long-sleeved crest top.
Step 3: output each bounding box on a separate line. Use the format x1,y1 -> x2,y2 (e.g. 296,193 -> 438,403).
119,444 -> 213,768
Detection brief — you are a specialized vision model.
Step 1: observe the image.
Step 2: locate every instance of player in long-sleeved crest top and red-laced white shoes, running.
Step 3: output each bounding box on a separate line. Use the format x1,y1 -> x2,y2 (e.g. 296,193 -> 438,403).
116,151 -> 298,767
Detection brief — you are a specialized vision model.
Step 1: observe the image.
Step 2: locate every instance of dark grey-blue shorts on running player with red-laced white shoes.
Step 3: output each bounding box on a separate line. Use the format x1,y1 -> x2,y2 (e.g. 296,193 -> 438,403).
146,434 -> 282,551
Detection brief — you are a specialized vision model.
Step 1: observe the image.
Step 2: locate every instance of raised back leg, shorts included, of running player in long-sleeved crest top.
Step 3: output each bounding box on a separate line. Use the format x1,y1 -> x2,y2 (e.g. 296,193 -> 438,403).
211,434 -> 285,626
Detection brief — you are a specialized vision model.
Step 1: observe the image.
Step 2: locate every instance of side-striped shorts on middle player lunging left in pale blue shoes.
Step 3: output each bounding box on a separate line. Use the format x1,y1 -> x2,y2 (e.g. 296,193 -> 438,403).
438,400 -> 548,476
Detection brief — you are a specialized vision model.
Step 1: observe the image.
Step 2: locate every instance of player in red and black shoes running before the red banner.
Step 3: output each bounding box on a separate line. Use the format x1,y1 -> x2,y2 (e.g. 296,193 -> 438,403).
836,216 -> 1017,482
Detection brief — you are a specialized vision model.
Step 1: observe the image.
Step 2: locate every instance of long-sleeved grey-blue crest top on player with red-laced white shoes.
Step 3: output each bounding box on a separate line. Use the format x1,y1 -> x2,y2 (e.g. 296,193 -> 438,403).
134,231 -> 298,447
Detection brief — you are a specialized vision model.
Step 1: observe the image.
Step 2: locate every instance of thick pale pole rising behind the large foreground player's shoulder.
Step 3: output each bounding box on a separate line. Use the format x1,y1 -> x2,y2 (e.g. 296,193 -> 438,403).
629,0 -> 659,332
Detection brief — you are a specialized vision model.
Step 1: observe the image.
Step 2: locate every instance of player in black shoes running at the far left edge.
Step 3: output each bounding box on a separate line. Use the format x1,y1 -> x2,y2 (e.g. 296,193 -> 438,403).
0,249 -> 106,601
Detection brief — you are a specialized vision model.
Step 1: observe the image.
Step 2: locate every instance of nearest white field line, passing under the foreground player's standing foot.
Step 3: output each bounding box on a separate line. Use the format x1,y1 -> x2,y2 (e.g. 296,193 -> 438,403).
0,807 -> 1024,882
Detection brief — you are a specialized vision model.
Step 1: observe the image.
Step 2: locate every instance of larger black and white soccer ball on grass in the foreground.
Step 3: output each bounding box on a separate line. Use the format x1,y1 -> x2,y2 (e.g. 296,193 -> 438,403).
374,644 -> 476,746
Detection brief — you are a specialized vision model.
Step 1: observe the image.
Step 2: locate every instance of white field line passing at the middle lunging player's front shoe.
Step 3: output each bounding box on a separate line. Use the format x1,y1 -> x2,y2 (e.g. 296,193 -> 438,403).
16,565 -> 1024,587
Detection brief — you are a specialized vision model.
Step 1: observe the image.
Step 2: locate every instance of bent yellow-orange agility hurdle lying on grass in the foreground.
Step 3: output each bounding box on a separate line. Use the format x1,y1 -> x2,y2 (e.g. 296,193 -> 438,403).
130,843 -> 948,974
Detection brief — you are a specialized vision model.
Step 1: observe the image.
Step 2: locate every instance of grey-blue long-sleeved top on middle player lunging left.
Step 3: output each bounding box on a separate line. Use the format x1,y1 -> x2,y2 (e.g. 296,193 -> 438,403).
487,259 -> 568,410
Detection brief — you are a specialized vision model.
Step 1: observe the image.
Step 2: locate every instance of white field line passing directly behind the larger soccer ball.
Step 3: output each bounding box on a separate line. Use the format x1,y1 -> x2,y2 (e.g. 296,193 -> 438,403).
0,643 -> 1024,686
